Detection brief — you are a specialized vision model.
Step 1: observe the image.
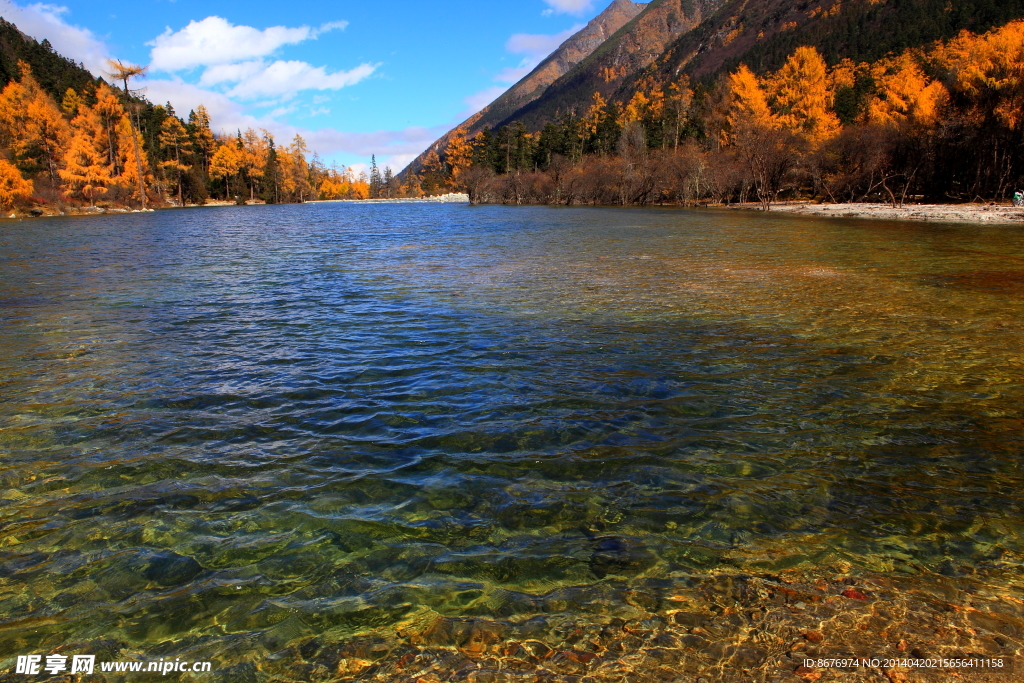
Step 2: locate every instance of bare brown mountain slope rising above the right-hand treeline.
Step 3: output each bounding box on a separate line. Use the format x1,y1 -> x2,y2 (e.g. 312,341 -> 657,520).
401,0 -> 1024,176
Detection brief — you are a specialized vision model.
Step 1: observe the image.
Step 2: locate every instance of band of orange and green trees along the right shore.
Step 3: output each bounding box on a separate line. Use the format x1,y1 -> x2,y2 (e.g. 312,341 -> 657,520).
420,22 -> 1024,208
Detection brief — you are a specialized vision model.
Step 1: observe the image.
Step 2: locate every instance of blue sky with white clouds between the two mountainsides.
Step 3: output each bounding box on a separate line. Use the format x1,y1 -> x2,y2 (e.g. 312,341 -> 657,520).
0,0 -> 610,171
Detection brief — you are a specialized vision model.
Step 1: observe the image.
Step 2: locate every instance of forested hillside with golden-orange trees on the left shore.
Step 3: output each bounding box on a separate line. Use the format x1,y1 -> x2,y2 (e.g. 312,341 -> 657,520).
0,19 -> 403,215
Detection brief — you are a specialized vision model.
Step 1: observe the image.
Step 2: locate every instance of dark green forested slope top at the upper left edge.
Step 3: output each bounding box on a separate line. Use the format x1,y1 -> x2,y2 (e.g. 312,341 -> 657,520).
0,16 -> 96,99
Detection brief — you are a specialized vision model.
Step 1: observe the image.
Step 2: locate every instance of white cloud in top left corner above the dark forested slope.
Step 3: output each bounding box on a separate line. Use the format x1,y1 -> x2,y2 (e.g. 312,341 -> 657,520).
0,0 -> 110,76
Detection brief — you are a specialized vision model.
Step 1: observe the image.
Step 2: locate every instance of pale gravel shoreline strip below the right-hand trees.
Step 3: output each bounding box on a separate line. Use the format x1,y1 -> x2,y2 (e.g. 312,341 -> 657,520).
737,202 -> 1024,224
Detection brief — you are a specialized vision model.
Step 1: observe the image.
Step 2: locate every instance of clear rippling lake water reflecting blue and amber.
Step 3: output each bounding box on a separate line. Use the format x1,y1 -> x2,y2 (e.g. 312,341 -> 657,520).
0,205 -> 1024,683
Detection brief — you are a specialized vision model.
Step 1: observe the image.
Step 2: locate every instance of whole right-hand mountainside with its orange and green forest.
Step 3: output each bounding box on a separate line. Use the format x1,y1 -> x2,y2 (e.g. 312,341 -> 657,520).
404,0 -> 1024,208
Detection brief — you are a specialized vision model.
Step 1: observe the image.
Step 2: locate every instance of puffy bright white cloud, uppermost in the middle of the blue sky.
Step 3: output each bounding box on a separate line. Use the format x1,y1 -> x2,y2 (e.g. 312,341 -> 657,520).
147,16 -> 348,72
